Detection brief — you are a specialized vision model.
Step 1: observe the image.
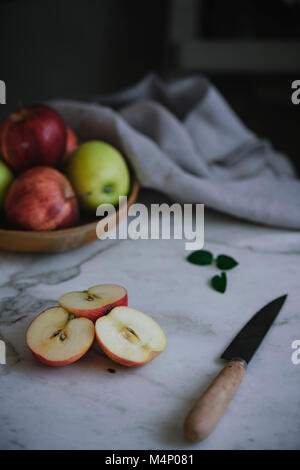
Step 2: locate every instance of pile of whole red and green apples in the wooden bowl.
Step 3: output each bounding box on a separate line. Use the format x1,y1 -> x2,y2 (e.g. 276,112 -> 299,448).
0,104 -> 130,231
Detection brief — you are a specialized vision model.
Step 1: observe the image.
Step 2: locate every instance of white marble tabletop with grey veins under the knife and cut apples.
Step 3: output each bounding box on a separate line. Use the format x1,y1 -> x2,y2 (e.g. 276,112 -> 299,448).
0,192 -> 300,450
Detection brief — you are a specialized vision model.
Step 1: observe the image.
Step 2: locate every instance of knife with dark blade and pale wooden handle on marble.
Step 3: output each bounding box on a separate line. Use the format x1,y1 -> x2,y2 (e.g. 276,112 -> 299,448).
184,295 -> 287,442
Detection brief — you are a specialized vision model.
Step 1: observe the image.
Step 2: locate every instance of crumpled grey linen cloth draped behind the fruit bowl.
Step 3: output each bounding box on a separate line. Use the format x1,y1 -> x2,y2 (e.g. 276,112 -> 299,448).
50,75 -> 300,229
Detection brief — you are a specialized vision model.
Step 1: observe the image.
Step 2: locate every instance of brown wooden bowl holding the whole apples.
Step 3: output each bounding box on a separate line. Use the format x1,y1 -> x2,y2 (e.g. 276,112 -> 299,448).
0,177 -> 139,253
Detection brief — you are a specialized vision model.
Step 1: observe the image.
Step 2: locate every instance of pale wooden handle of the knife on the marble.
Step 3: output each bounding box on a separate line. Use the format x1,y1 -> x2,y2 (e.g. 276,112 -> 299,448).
184,359 -> 246,442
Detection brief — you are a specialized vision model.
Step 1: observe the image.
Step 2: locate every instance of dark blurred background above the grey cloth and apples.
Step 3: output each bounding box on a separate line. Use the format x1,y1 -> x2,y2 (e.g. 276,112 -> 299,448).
0,0 -> 300,171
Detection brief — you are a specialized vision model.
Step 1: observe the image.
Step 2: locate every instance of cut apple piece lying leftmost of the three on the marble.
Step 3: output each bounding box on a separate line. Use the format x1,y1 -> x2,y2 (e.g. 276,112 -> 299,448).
26,307 -> 95,366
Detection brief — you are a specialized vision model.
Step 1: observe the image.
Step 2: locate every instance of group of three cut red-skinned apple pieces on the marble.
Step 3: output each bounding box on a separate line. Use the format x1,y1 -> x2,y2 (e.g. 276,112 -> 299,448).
26,284 -> 167,367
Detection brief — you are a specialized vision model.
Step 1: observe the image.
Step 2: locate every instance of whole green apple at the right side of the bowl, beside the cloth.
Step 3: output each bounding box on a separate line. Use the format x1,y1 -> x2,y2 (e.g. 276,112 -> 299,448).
66,140 -> 130,210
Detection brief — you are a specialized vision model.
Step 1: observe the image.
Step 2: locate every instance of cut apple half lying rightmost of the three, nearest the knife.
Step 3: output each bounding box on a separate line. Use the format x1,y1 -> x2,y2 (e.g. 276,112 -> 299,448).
95,307 -> 167,367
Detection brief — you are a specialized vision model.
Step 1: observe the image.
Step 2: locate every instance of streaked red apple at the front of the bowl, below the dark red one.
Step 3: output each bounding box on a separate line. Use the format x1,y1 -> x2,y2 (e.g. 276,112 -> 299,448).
4,167 -> 79,231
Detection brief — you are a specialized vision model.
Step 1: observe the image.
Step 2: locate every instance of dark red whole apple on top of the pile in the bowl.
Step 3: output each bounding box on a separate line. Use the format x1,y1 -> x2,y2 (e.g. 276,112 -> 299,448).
0,104 -> 66,172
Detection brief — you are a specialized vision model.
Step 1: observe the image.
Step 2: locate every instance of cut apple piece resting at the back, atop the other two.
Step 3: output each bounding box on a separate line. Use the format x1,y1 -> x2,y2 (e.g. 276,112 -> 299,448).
58,284 -> 128,322
